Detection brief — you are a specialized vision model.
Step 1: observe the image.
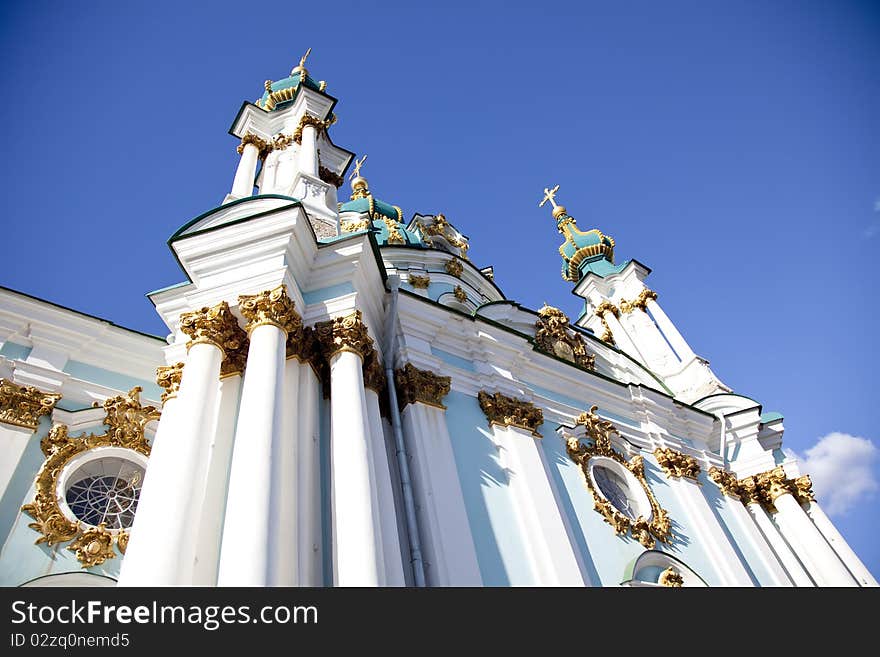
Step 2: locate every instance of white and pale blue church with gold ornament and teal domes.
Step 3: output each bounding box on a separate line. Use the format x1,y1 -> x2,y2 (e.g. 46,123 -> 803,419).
0,52 -> 877,588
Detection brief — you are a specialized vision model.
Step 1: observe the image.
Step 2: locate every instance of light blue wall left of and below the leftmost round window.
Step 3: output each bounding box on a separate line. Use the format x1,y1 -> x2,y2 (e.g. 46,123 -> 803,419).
0,416 -> 121,586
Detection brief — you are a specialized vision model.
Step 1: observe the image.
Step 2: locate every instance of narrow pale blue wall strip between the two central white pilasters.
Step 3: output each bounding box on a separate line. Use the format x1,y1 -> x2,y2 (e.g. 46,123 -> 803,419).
444,392 -> 535,586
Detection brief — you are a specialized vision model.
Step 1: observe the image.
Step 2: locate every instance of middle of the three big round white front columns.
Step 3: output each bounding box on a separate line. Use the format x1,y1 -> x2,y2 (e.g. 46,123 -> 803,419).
217,323 -> 287,586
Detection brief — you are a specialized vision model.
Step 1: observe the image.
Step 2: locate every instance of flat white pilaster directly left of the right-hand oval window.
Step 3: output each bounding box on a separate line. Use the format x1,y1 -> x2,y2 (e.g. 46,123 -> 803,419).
492,424 -> 587,586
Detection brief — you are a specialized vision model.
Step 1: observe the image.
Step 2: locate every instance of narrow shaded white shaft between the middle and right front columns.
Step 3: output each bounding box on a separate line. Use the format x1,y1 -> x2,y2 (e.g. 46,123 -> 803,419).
296,364 -> 324,586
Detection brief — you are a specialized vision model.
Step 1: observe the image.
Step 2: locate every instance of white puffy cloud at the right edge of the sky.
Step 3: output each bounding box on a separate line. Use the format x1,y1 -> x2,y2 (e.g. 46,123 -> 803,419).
801,431 -> 880,515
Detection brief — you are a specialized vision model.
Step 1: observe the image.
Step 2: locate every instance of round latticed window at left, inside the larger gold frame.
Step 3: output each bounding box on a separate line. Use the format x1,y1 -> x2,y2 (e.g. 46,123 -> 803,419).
58,447 -> 146,530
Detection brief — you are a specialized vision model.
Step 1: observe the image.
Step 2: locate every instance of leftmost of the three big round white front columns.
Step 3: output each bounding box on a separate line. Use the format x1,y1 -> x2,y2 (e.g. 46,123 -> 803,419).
119,340 -> 223,586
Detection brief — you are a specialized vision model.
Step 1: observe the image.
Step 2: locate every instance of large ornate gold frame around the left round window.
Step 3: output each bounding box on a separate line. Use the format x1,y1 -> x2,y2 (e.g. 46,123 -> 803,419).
21,386 -> 160,568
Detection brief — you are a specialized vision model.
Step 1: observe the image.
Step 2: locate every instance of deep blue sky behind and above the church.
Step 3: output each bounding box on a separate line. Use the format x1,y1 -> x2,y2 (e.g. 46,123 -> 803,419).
0,0 -> 880,577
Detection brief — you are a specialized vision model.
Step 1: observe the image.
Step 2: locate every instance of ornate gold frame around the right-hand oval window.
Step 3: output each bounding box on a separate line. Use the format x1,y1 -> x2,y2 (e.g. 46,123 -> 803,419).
567,406 -> 673,549
